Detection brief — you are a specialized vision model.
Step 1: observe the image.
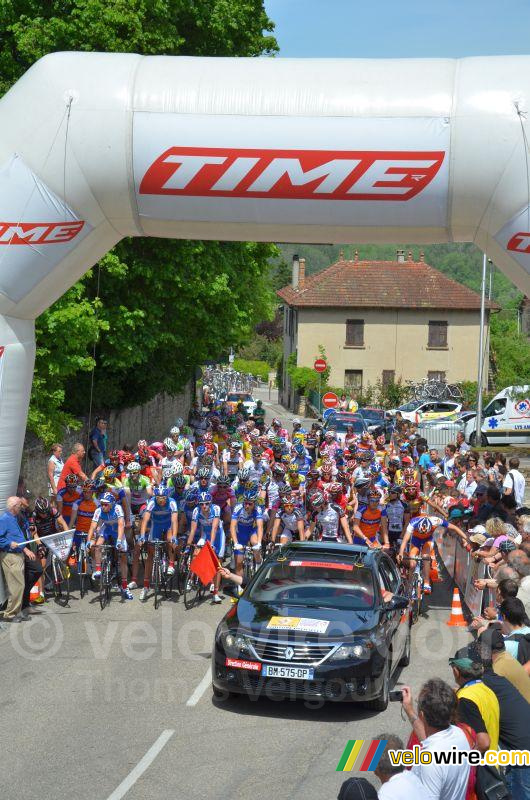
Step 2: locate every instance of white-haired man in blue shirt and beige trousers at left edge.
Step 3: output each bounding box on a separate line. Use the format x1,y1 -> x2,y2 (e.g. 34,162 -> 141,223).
0,497 -> 42,623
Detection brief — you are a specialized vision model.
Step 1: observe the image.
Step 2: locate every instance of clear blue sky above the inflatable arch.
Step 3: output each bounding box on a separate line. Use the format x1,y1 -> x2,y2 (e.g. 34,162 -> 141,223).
265,0 -> 530,58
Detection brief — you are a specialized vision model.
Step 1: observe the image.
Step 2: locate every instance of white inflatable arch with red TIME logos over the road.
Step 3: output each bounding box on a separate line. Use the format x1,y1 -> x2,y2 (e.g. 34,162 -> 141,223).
0,53 -> 530,502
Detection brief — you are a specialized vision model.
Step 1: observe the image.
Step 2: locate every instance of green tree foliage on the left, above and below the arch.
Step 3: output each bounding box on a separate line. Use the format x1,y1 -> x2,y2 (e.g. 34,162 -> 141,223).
0,0 -> 278,441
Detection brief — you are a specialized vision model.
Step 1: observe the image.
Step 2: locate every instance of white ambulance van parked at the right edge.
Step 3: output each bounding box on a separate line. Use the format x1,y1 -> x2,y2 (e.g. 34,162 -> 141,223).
464,384 -> 530,447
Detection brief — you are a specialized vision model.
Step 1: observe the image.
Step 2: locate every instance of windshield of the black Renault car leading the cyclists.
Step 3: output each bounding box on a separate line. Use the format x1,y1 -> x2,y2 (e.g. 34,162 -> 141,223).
245,557 -> 375,611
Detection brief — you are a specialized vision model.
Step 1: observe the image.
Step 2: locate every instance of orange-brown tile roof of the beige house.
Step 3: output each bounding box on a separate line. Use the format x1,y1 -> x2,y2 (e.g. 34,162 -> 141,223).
277,259 -> 499,310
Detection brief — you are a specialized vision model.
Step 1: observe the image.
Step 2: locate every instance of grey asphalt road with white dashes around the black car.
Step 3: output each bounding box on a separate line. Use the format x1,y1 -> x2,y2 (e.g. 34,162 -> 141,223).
0,394 -> 469,800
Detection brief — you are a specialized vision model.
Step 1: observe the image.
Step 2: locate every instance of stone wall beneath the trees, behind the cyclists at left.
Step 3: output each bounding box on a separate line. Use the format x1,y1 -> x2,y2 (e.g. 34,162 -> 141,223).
20,382 -> 193,496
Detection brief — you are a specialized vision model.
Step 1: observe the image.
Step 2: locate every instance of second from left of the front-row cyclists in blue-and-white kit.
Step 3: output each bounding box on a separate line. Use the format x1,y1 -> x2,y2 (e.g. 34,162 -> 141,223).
139,486 -> 178,601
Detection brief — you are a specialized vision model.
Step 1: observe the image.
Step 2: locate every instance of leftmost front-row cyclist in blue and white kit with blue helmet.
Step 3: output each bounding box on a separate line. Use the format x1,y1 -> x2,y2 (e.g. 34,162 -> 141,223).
87,492 -> 134,600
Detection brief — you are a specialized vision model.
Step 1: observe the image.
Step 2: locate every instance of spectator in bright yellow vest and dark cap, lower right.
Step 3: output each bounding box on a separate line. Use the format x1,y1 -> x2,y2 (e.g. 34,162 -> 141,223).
449,658 -> 500,753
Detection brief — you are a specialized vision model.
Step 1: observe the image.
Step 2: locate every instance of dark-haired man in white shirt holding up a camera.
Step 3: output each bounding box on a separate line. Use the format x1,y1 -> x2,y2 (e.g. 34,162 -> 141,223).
402,678 -> 470,800
